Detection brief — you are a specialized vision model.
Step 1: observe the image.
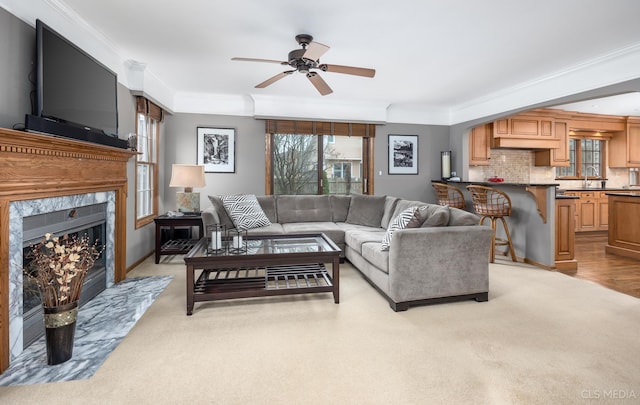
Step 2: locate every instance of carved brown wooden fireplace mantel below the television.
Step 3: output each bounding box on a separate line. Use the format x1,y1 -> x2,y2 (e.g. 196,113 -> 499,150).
0,128 -> 135,373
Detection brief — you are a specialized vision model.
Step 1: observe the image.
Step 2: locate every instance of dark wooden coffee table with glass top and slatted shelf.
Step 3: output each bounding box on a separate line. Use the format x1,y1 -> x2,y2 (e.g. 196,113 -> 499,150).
184,234 -> 341,315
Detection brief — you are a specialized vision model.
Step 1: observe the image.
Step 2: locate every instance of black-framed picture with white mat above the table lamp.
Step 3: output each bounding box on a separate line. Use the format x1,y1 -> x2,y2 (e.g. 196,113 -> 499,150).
198,127 -> 236,173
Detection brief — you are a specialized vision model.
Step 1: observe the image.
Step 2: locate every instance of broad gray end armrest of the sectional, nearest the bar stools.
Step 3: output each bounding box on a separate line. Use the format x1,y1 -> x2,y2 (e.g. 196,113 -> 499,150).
389,225 -> 492,302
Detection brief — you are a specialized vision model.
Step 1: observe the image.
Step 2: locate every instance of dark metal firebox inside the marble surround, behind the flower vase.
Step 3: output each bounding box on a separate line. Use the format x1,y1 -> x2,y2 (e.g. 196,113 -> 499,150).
22,203 -> 107,349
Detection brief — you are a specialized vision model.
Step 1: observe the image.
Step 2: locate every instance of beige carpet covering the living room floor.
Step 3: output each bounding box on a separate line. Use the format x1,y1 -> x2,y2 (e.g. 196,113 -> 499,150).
0,256 -> 640,404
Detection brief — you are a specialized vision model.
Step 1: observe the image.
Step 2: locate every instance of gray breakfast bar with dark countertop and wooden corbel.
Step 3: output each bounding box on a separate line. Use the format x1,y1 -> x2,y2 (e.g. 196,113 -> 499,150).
432,180 -> 558,270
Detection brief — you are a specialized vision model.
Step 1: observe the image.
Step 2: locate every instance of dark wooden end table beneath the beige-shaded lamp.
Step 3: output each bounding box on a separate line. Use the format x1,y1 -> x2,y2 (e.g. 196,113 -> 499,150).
153,213 -> 204,264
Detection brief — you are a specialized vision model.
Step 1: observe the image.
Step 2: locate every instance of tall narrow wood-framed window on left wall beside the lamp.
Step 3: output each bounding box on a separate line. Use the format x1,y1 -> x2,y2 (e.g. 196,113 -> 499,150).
136,97 -> 162,228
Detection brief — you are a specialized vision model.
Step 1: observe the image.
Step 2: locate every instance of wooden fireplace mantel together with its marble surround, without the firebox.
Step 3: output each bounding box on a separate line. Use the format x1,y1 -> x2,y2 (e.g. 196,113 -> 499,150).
0,128 -> 135,373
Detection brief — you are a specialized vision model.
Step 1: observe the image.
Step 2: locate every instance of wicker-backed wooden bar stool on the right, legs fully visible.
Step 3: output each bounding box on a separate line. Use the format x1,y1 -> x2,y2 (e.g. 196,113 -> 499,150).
467,185 -> 518,263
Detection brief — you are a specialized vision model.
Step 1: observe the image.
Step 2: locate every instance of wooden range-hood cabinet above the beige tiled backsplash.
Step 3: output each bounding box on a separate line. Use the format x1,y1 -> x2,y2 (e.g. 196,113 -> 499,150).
492,114 -> 560,149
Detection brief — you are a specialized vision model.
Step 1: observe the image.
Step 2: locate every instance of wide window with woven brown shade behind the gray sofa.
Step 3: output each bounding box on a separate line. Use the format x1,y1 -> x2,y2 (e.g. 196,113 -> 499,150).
265,120 -> 375,194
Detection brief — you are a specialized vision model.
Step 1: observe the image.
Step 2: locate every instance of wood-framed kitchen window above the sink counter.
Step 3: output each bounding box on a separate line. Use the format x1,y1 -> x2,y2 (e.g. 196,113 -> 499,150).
556,137 -> 606,179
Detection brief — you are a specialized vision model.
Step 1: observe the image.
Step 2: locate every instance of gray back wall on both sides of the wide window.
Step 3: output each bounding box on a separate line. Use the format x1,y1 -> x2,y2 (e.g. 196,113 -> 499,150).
163,114 -> 449,209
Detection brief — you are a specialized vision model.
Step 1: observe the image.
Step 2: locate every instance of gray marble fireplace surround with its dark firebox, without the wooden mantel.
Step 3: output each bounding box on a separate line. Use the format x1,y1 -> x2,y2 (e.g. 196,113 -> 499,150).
9,192 -> 115,359
